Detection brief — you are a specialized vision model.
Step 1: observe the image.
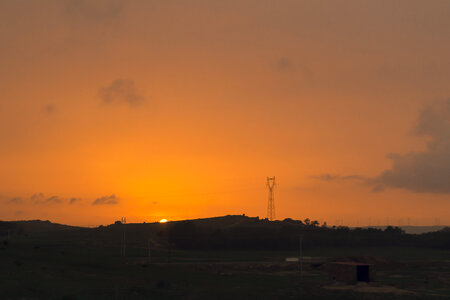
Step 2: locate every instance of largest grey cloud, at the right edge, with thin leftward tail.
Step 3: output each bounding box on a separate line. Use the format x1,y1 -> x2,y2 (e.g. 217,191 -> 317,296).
314,99 -> 450,194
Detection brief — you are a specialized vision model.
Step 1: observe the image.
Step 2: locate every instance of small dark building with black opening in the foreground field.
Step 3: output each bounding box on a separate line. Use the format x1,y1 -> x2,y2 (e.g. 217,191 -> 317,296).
328,262 -> 375,283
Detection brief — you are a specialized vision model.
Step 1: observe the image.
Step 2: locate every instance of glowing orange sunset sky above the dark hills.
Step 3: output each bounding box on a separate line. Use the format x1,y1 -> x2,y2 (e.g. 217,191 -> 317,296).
0,0 -> 450,226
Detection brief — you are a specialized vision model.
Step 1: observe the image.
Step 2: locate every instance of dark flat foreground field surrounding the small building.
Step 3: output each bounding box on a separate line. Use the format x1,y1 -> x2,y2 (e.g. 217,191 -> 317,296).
0,237 -> 450,299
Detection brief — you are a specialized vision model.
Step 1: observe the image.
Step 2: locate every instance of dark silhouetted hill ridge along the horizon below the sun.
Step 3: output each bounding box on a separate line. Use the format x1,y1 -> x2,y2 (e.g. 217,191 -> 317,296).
0,215 -> 450,250
